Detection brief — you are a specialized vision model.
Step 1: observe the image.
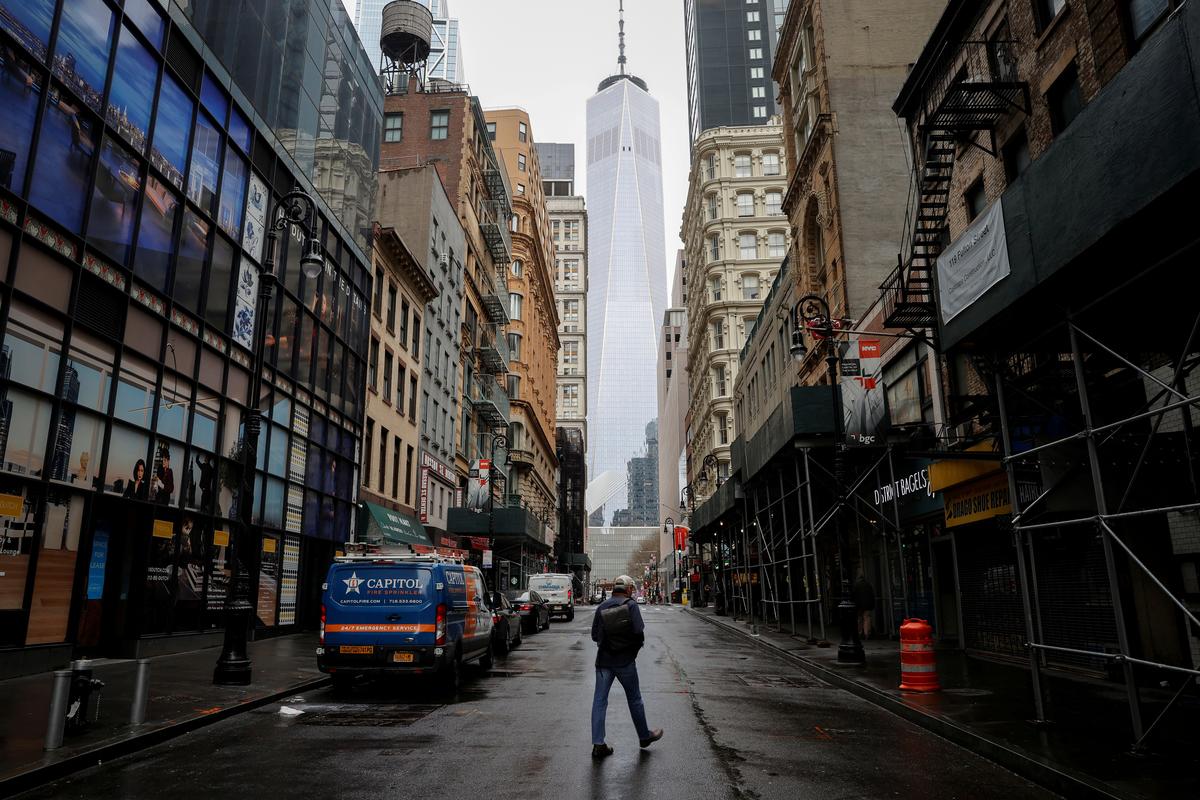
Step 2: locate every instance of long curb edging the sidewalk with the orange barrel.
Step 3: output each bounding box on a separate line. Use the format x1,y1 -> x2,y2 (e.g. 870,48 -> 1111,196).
685,608 -> 1128,800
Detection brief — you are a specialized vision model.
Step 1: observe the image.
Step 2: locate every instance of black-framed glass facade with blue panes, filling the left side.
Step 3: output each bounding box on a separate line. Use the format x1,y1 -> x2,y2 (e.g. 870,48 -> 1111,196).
0,0 -> 382,655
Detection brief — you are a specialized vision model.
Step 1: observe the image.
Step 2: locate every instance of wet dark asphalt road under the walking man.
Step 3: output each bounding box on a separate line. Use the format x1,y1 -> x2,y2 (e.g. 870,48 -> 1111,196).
14,607 -> 1054,800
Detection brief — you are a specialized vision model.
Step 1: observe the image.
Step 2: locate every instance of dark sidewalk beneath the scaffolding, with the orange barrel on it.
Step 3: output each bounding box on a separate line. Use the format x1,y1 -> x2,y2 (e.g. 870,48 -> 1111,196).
688,607 -> 1200,800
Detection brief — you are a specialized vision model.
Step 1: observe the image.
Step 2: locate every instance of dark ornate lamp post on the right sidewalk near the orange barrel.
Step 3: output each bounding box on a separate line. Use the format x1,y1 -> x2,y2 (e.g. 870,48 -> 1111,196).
788,295 -> 866,664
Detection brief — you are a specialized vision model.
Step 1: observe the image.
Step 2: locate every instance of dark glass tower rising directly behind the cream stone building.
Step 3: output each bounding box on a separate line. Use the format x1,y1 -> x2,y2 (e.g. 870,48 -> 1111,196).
686,0 -> 790,143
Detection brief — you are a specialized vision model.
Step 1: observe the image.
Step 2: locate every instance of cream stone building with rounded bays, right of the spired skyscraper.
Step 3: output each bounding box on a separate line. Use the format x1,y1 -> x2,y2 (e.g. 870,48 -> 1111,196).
682,121 -> 790,493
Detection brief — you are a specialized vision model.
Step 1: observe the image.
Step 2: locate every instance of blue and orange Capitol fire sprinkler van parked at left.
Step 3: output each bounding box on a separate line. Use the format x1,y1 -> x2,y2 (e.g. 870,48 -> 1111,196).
317,554 -> 492,691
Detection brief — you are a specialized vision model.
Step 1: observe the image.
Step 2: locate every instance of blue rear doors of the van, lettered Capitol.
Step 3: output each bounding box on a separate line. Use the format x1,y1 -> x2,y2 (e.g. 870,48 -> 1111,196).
325,561 -> 438,646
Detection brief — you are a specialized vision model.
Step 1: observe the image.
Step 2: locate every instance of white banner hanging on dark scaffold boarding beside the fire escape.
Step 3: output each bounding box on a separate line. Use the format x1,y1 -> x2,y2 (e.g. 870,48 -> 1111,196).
937,200 -> 1010,323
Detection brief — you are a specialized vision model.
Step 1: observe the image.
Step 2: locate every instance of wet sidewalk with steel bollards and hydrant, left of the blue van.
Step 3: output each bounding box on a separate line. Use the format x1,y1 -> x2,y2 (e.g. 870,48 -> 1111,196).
0,633 -> 328,796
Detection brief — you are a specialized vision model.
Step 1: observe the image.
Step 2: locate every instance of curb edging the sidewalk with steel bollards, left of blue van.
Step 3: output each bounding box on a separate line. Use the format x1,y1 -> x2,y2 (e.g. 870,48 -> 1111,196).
0,676 -> 331,798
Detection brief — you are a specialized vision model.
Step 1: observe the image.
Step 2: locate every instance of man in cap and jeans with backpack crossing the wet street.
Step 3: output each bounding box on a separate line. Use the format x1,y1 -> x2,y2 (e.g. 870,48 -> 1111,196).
592,575 -> 662,758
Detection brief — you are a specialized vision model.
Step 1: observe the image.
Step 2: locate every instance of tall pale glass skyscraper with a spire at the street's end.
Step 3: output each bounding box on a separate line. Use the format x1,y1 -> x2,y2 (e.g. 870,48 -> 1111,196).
587,4 -> 666,525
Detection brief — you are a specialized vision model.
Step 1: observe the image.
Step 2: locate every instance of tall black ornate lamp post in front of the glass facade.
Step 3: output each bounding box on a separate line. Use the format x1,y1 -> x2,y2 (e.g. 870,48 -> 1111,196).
212,190 -> 325,686
